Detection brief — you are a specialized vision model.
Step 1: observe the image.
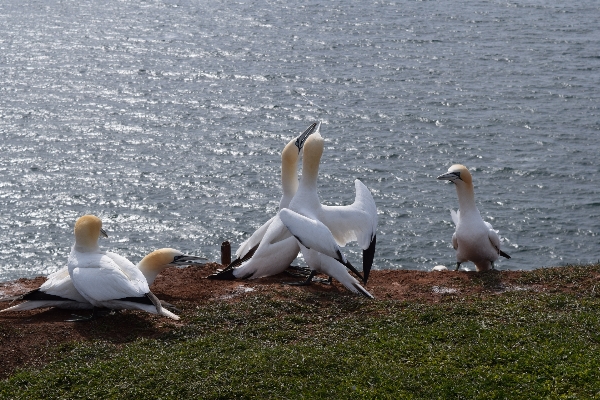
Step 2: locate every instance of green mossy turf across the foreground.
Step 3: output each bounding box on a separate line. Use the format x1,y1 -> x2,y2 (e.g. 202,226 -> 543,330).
0,265 -> 600,399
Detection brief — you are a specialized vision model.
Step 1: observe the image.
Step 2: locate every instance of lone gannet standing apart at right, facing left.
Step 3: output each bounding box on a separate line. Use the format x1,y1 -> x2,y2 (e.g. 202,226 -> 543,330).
437,164 -> 510,271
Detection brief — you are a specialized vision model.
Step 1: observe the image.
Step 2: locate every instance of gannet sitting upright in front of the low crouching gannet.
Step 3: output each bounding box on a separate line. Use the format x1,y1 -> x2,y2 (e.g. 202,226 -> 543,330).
68,215 -> 179,320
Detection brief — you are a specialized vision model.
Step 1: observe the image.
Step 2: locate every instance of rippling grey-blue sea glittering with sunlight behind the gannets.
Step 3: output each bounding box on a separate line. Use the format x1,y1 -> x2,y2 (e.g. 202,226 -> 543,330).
0,0 -> 600,281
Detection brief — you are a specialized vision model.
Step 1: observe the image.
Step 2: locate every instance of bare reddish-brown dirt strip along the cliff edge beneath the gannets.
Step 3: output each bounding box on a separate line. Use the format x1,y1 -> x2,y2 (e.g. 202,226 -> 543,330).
0,263 -> 597,379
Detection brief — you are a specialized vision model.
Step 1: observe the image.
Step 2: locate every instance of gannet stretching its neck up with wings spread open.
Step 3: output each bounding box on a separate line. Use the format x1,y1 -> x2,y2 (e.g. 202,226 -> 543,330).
279,132 -> 377,297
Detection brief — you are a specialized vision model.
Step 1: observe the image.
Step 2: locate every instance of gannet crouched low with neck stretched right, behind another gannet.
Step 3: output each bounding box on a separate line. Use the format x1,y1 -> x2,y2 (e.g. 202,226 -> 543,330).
0,248 -> 205,312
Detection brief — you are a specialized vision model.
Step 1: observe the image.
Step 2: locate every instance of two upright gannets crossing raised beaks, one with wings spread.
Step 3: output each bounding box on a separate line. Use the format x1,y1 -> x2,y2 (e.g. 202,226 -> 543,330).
213,123 -> 377,298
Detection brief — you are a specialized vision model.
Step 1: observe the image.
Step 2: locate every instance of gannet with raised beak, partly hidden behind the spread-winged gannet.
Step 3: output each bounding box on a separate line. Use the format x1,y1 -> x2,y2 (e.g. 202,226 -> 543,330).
209,122 -> 321,279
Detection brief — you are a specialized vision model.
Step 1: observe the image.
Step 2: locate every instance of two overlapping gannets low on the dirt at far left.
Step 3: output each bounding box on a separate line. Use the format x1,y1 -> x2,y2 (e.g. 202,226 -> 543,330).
1,215 -> 204,319
